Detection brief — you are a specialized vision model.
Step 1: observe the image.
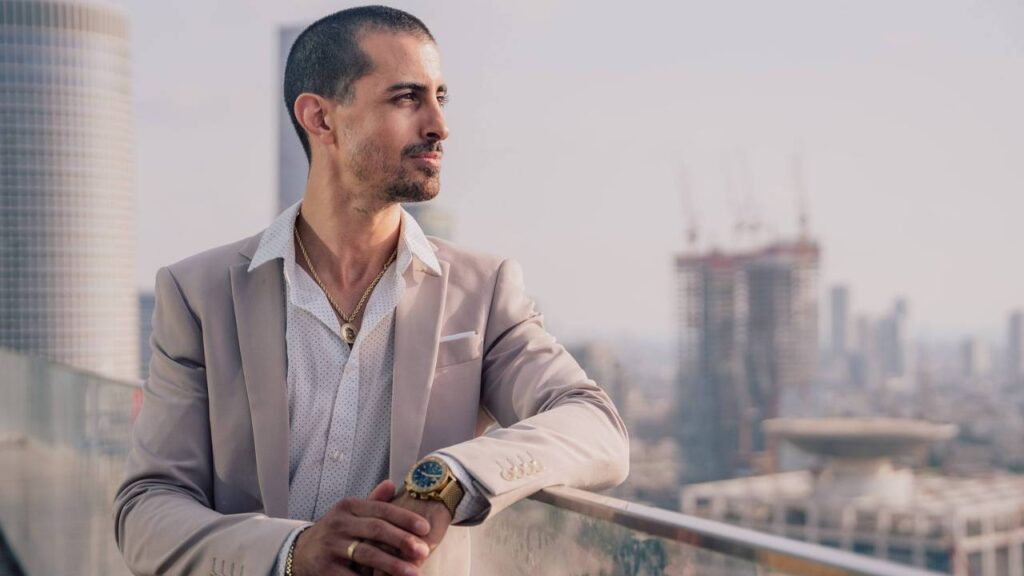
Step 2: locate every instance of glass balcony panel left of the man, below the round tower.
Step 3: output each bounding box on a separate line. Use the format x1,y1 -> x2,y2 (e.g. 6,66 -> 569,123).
0,342 -> 141,576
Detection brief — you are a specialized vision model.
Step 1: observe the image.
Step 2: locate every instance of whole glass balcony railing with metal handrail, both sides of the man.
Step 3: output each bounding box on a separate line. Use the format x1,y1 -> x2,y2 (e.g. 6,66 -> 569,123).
0,349 -> 931,576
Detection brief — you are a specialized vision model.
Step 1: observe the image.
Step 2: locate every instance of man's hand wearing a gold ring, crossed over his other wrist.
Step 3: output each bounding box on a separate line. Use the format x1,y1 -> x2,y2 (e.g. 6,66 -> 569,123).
292,480 -> 430,576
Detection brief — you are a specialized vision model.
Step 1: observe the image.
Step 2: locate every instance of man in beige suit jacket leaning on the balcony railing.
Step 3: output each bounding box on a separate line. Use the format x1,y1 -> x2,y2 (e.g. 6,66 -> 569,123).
114,6 -> 628,576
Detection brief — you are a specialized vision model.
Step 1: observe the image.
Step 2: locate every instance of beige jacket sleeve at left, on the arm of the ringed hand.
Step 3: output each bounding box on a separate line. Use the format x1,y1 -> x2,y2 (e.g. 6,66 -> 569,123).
114,269 -> 305,576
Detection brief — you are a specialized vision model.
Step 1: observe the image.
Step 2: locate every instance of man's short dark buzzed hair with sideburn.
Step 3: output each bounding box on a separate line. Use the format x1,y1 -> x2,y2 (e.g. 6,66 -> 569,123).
285,6 -> 434,162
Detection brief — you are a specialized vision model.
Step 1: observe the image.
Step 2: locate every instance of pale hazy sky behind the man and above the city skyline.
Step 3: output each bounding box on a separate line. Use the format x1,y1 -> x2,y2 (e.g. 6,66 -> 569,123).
118,0 -> 1024,339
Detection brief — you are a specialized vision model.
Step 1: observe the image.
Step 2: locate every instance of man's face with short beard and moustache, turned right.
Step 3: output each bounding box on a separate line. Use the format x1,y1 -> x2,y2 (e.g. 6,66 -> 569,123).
332,32 -> 449,203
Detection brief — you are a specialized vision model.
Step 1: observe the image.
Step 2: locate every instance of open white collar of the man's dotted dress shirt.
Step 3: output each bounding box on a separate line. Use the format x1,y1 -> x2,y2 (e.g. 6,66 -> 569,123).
249,200 -> 441,276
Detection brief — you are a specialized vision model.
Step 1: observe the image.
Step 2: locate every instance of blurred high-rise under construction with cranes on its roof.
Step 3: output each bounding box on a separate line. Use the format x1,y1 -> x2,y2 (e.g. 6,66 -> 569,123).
676,235 -> 819,482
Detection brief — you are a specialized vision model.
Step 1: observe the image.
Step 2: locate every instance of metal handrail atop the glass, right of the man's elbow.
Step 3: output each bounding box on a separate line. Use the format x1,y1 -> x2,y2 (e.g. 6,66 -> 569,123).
530,486 -> 940,576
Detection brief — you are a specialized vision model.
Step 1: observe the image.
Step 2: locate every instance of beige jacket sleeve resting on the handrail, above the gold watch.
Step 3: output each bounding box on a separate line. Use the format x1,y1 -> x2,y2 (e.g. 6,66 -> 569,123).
442,260 -> 629,523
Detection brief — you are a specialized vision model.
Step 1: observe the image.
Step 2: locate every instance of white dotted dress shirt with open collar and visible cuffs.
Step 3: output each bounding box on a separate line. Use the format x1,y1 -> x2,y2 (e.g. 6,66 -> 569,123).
249,202 -> 487,574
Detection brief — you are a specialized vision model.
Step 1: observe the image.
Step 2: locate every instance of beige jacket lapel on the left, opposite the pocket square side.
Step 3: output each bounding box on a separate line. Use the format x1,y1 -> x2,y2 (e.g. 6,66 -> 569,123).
230,254 -> 288,518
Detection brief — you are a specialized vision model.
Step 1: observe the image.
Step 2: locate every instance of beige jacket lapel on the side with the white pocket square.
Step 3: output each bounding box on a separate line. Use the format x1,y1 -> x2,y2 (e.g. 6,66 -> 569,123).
390,260 -> 449,486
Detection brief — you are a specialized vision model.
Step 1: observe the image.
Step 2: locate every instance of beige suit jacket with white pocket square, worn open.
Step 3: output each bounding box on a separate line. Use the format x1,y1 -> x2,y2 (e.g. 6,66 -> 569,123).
114,229 -> 629,576
